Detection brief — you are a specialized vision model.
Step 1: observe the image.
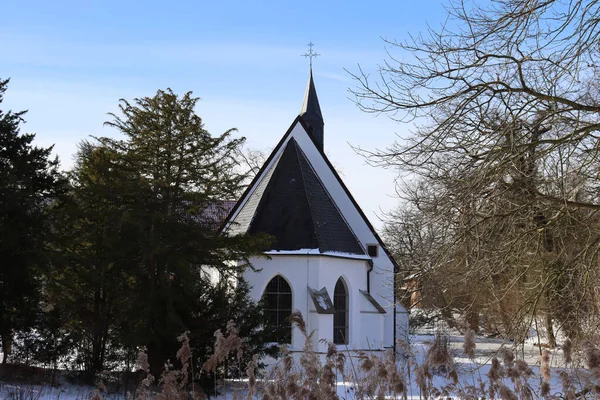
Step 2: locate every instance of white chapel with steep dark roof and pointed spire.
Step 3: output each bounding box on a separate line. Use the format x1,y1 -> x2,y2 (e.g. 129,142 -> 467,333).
224,66 -> 408,352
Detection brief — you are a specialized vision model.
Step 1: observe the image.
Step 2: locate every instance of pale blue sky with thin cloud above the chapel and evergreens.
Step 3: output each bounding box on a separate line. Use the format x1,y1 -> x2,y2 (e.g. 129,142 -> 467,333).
0,0 -> 445,227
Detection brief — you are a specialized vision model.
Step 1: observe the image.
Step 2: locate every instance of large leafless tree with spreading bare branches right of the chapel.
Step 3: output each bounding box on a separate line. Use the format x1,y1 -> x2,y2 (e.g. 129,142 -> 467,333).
354,0 -> 600,344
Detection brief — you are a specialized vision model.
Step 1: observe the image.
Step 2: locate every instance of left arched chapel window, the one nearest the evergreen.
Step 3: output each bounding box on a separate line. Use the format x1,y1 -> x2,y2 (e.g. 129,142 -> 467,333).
263,275 -> 292,343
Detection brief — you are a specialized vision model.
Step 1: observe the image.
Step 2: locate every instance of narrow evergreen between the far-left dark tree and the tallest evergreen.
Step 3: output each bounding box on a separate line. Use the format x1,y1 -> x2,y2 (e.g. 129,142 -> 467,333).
47,142 -> 135,381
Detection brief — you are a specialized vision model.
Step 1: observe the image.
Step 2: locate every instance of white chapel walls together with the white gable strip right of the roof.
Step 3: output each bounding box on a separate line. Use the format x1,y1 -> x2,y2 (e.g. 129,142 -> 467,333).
227,123 -> 407,349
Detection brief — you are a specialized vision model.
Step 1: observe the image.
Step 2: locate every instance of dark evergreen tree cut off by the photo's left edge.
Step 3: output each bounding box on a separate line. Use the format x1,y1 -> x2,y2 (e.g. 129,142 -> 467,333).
0,79 -> 63,363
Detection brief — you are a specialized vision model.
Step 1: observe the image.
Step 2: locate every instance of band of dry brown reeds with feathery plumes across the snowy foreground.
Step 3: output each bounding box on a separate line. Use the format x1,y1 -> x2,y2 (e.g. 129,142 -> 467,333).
5,312 -> 600,400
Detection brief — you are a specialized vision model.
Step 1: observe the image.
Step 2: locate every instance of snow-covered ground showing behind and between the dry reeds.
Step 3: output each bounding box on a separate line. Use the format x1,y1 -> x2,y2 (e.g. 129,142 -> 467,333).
0,334 -> 590,400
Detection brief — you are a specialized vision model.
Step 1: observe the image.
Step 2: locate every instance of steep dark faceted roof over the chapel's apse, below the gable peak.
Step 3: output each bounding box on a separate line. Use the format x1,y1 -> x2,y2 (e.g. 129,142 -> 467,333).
247,138 -> 365,254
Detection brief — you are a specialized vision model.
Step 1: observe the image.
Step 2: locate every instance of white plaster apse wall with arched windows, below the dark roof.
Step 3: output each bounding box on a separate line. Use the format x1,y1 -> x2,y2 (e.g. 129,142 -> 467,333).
244,255 -> 391,351
